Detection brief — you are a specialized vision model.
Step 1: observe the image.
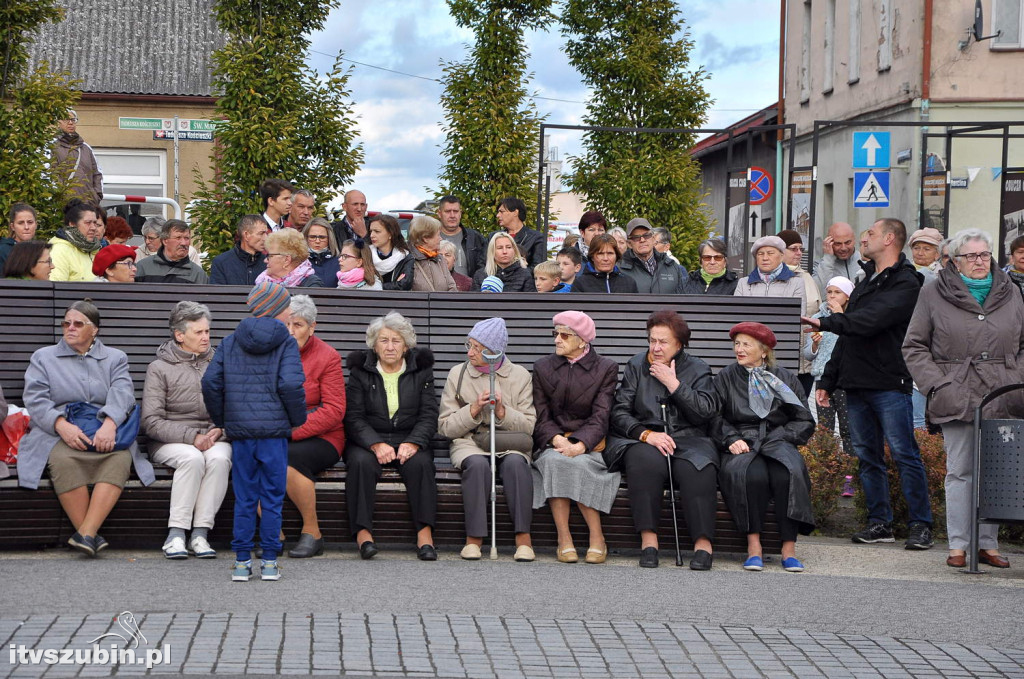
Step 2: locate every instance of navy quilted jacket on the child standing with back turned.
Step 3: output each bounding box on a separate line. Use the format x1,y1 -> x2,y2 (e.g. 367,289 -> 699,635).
203,317 -> 306,438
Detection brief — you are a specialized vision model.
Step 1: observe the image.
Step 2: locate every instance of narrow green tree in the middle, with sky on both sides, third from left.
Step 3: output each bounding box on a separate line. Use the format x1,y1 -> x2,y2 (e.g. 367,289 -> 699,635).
438,0 -> 554,234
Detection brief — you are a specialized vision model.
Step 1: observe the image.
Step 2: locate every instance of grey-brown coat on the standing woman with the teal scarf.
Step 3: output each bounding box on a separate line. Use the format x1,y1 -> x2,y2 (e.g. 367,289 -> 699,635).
903,266 -> 1024,424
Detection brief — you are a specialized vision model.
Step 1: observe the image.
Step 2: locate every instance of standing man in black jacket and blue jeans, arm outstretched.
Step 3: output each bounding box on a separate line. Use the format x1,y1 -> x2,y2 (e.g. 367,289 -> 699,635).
803,218 -> 933,549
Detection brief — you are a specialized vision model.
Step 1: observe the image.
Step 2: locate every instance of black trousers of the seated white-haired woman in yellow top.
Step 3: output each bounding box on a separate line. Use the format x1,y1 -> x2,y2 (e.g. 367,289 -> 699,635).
345,443 -> 437,539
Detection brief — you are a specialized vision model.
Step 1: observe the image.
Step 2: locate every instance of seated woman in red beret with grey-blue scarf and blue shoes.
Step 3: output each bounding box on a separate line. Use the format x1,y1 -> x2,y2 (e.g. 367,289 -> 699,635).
710,323 -> 814,572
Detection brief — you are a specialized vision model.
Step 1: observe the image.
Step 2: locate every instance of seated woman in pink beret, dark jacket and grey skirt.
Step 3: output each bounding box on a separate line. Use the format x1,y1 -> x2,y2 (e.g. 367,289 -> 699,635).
534,311 -> 622,563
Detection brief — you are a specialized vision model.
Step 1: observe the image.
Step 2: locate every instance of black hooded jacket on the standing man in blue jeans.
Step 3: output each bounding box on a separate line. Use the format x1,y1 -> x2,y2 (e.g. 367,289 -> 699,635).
819,253 -> 924,393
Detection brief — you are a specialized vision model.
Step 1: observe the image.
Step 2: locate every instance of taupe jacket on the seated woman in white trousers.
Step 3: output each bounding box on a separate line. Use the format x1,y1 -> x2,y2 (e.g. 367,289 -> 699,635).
142,340 -> 213,443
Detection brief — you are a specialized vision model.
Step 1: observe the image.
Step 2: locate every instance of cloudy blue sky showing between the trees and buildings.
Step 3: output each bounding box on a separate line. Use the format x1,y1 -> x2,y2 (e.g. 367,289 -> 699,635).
309,0 -> 778,210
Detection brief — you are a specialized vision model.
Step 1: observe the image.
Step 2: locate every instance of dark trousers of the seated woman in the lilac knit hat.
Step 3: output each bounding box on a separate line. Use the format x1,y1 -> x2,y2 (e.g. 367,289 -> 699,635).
462,453 -> 534,538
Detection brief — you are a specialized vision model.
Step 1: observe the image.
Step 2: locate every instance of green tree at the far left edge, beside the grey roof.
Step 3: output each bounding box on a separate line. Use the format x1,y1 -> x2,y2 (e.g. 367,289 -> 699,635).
0,0 -> 79,237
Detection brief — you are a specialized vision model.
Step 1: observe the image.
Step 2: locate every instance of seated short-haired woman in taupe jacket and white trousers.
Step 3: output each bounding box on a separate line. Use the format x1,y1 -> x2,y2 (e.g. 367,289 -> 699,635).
141,301 -> 231,559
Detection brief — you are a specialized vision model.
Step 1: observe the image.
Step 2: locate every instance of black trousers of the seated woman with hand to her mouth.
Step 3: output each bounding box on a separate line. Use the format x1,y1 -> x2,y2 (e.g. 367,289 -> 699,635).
625,443 -> 718,542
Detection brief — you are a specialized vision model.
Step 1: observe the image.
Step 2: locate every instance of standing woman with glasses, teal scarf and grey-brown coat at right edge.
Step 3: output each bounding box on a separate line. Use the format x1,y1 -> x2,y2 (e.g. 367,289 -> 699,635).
903,228 -> 1024,568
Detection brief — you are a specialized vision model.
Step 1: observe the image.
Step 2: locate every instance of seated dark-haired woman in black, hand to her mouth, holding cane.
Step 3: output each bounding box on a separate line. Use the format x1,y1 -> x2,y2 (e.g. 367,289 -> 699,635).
604,310 -> 718,570
